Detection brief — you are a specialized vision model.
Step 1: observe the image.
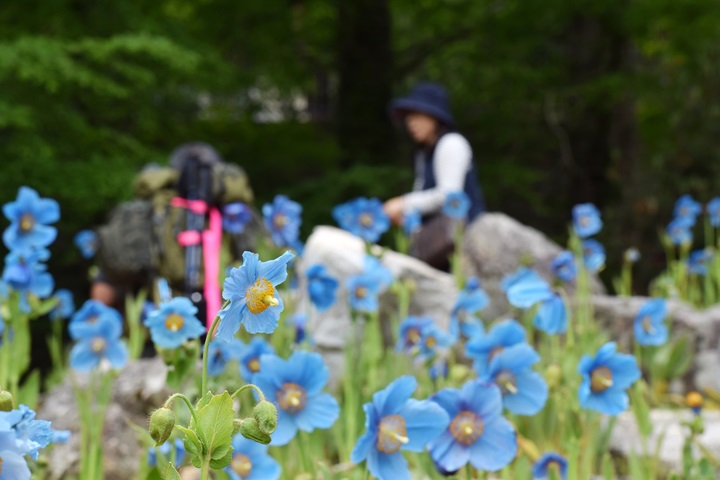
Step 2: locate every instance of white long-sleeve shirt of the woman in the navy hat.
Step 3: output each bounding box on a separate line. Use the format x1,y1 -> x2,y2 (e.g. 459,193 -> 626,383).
403,133 -> 472,215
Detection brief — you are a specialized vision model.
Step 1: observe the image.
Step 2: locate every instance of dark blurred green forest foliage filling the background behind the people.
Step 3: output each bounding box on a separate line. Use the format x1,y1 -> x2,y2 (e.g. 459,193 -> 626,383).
0,0 -> 720,296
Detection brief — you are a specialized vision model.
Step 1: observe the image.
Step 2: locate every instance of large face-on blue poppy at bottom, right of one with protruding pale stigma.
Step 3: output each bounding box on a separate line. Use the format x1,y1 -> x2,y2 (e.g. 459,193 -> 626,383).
429,380 -> 517,472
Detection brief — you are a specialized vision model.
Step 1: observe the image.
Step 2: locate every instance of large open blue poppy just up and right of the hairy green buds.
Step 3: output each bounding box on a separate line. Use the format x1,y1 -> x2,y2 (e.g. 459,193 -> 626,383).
253,350 -> 340,445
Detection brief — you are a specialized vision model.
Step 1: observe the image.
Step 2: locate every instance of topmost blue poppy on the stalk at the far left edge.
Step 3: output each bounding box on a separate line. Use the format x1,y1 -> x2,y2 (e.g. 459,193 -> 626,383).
3,187 -> 60,250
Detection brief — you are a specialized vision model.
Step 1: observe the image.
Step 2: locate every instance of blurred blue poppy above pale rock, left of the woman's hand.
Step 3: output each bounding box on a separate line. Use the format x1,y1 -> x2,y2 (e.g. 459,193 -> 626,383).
333,197 -> 390,243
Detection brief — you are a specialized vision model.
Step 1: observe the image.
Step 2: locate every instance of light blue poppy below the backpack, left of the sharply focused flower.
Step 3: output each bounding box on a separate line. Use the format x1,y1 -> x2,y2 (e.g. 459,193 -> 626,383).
145,297 -> 205,349
